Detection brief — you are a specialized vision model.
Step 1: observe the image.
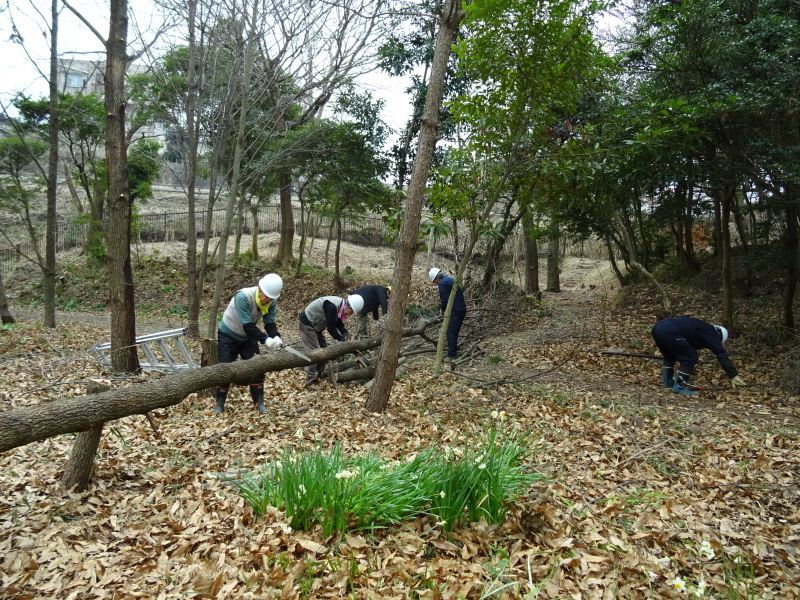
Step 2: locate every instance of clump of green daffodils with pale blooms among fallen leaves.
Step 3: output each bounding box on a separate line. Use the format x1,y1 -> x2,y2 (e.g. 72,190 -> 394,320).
237,413 -> 542,536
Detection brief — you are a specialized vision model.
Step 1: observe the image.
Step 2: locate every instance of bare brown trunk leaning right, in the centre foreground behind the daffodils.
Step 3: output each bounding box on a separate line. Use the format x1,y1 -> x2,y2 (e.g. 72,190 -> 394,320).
364,0 -> 464,412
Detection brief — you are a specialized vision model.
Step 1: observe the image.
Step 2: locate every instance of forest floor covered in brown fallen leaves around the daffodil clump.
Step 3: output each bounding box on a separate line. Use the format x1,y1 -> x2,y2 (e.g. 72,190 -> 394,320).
0,241 -> 800,599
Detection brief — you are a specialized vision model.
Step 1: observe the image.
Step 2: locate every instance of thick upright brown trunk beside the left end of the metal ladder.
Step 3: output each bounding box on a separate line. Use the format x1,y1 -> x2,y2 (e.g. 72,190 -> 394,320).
105,0 -> 139,373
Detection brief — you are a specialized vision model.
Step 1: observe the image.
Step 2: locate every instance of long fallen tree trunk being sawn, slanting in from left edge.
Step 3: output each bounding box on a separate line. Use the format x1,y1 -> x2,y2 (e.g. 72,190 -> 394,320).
0,328 -> 428,452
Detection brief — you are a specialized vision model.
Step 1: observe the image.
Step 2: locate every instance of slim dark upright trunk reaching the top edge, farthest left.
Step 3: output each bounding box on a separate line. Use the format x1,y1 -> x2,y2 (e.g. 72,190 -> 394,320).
44,0 -> 59,328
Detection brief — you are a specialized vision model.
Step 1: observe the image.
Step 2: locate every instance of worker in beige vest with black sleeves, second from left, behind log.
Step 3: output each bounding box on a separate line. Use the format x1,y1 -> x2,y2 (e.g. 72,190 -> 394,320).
298,294 -> 364,389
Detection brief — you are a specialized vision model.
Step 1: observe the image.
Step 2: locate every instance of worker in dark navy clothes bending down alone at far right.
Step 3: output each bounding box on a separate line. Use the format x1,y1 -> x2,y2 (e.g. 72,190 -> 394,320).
652,317 -> 746,395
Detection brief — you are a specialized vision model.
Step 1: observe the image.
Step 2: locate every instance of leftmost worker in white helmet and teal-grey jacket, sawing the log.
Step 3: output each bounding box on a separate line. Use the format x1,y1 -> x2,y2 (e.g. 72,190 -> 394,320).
214,273 -> 283,413
